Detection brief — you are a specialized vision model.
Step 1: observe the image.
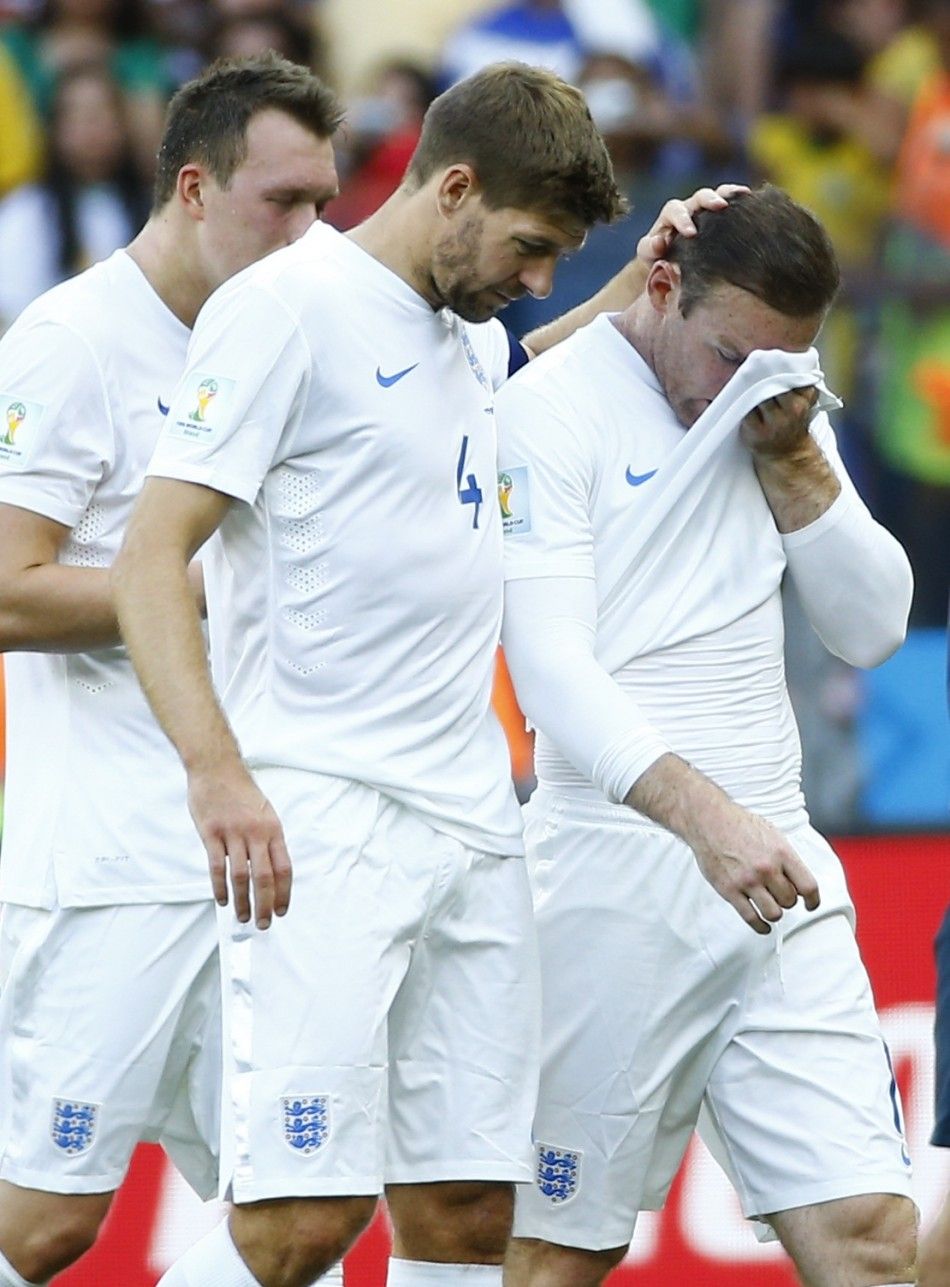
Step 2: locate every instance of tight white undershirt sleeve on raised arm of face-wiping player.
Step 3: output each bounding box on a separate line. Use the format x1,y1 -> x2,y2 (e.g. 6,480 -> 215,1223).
783,416 -> 914,667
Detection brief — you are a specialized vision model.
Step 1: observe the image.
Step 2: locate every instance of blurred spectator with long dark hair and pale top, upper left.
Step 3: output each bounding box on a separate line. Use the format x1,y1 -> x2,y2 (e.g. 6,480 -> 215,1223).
0,64 -> 148,328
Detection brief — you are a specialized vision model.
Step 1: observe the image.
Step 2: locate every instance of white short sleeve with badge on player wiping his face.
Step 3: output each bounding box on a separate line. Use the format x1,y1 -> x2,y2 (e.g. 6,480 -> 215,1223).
496,364 -> 593,580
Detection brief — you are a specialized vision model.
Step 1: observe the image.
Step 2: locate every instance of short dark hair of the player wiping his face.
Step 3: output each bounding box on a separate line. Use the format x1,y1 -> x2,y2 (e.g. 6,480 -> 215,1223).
667,184 -> 841,318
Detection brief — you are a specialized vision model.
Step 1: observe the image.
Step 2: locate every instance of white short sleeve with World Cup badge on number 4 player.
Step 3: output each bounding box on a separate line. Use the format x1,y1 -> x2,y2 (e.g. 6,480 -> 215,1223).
148,274 -> 312,503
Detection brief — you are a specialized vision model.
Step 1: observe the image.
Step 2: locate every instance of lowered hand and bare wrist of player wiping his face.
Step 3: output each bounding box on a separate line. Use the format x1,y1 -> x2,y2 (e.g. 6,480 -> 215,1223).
624,754 -> 820,934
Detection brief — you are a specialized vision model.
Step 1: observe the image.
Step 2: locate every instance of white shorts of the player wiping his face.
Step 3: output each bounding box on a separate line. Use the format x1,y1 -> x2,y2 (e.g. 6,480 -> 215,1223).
515,788 -> 911,1251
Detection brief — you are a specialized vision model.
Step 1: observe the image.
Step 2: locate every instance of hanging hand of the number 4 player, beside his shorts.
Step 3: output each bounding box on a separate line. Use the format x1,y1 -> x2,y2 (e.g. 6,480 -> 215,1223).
188,761 -> 291,929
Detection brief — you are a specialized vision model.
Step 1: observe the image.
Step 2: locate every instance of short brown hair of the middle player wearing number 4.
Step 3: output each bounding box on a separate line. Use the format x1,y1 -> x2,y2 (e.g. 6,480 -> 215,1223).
405,62 -> 627,228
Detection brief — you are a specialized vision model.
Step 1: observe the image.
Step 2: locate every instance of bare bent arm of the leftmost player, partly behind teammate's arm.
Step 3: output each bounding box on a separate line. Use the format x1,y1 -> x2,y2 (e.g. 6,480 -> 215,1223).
0,505 -> 203,653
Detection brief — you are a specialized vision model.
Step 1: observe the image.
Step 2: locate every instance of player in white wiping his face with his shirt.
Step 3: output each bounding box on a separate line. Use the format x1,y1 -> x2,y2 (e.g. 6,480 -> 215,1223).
497,188 -> 915,1287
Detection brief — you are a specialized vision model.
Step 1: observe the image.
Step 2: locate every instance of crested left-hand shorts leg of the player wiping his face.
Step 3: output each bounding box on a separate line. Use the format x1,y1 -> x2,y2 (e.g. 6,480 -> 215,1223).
515,793 -> 757,1250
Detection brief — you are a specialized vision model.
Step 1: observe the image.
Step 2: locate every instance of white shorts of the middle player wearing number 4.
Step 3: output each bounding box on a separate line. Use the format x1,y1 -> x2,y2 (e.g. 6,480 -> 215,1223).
219,768 -> 539,1202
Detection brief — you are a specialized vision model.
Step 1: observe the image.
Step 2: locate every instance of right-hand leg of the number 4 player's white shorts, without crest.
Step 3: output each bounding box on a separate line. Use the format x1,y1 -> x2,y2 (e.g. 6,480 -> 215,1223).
386,844 -> 539,1185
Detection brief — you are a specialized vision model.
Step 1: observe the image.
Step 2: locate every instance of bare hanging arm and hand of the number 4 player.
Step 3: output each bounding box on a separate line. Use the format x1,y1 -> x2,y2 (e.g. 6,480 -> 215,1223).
113,479 -> 291,929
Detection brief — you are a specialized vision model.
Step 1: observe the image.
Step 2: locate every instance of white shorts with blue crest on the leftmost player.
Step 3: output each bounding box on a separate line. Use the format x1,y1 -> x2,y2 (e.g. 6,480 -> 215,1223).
0,900 -> 220,1198
